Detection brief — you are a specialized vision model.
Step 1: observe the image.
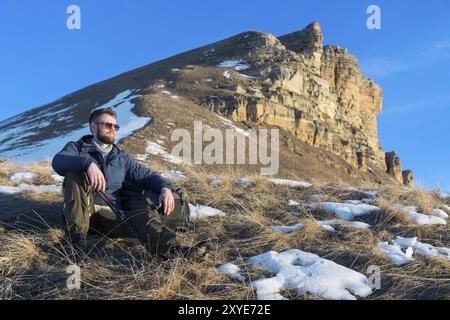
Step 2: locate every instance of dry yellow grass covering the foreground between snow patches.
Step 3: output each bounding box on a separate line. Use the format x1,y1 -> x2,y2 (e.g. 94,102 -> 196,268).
0,162 -> 450,299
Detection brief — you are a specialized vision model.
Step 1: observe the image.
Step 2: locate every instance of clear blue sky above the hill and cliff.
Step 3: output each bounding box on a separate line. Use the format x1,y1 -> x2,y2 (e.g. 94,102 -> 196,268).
0,0 -> 450,192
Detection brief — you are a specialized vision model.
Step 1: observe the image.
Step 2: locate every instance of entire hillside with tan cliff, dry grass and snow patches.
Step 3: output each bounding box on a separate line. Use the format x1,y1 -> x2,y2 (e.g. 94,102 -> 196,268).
0,23 -> 450,300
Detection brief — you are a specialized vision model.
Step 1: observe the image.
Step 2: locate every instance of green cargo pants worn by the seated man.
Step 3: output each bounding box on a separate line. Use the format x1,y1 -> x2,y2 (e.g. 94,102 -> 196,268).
63,172 -> 189,255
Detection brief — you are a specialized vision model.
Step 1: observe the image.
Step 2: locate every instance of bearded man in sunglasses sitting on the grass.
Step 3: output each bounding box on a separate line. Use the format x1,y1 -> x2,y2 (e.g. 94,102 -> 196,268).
52,109 -> 189,255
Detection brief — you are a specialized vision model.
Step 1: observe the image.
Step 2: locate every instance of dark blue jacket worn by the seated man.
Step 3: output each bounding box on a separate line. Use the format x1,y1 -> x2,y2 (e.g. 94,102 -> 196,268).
52,135 -> 173,208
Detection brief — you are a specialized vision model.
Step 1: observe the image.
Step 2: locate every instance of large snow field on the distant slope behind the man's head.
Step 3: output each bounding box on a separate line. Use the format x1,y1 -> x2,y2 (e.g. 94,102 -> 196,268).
0,90 -> 146,162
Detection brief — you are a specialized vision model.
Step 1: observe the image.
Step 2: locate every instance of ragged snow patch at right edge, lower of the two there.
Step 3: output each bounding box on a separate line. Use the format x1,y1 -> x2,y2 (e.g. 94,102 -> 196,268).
378,237 -> 450,265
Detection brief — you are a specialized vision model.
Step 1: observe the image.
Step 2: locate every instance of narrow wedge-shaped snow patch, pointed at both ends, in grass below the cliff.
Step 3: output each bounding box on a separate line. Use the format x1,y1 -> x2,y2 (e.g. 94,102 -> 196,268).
305,202 -> 380,221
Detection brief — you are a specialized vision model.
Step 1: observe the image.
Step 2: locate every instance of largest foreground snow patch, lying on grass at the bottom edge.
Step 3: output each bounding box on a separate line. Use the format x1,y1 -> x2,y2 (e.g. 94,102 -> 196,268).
249,249 -> 372,300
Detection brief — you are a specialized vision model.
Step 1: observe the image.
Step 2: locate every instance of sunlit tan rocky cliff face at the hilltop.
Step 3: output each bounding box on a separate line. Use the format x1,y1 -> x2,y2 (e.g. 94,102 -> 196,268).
202,23 -> 410,183
